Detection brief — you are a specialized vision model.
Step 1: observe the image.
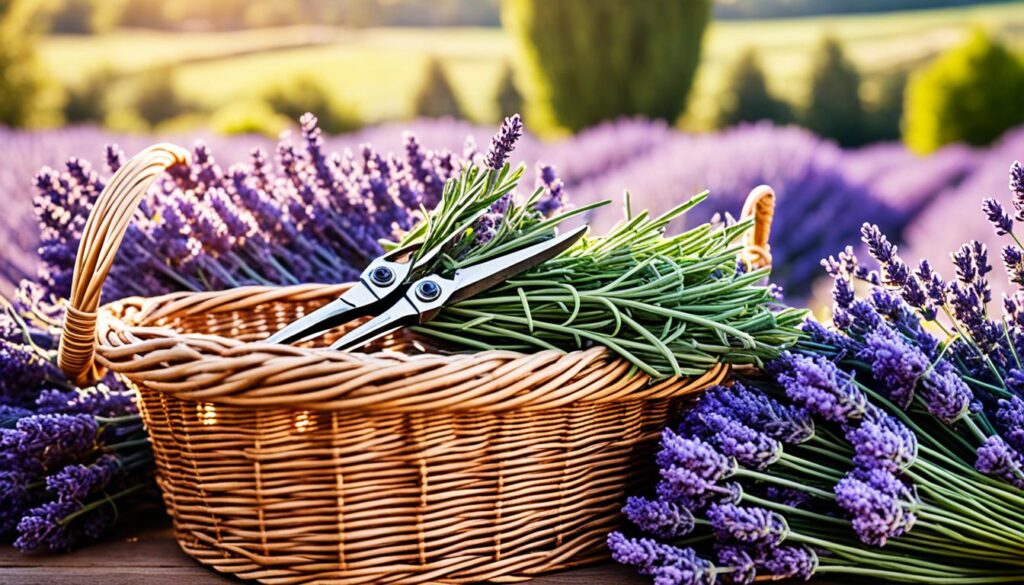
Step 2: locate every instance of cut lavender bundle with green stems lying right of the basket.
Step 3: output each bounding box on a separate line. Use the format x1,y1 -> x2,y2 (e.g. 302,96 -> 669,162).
608,157 -> 1024,584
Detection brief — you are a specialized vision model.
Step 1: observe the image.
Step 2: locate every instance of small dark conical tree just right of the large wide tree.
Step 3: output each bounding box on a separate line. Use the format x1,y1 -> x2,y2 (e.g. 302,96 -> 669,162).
718,48 -> 793,127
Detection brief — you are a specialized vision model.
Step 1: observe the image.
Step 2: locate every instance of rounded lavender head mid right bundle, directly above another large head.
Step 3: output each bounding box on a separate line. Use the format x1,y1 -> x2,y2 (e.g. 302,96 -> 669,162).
846,407 -> 918,472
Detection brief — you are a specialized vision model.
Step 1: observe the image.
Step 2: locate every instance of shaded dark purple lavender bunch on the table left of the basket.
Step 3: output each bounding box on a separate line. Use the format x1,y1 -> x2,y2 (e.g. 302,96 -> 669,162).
0,295 -> 157,551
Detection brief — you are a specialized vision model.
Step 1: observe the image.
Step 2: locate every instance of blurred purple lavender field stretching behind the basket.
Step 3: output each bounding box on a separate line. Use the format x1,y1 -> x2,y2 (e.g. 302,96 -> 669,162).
0,120 -> 1024,301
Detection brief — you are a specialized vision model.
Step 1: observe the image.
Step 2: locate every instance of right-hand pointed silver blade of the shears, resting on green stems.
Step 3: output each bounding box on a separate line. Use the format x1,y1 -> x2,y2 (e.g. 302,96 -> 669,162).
445,225 -> 588,304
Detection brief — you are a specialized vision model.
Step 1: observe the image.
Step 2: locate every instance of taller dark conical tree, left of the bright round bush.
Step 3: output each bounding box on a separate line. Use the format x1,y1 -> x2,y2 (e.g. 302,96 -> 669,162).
804,37 -> 864,147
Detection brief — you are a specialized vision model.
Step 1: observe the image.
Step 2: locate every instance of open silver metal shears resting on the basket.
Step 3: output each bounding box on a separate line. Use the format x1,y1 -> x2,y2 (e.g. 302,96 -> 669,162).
266,225 -> 588,349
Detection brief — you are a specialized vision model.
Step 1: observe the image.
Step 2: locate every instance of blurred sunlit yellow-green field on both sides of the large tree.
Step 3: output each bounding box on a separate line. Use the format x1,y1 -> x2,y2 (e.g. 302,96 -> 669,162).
41,4 -> 1024,128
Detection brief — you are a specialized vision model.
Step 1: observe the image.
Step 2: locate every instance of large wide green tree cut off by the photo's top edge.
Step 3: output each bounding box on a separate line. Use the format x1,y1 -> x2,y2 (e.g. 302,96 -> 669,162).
502,0 -> 711,131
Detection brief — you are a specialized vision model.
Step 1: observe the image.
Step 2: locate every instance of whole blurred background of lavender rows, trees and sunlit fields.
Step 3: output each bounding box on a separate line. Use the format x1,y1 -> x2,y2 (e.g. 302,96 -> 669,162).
0,0 -> 1024,304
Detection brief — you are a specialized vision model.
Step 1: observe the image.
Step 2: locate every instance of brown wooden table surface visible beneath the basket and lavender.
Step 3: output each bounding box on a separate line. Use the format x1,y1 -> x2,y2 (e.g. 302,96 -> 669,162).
0,523 -> 650,585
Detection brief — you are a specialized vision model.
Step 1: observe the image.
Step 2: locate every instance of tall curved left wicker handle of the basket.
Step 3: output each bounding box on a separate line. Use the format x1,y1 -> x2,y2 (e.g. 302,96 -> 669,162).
57,143 -> 188,385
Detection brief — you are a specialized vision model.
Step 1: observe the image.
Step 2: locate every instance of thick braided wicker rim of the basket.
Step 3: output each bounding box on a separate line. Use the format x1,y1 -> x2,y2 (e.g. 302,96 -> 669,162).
88,283 -> 729,412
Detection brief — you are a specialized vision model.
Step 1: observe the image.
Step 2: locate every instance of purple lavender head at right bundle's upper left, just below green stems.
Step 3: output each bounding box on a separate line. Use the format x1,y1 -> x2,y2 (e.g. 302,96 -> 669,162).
769,352 -> 867,423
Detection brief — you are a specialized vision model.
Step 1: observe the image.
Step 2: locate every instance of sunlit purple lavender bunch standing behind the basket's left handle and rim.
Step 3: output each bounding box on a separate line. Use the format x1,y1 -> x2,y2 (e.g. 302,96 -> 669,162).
35,115 -> 460,299
